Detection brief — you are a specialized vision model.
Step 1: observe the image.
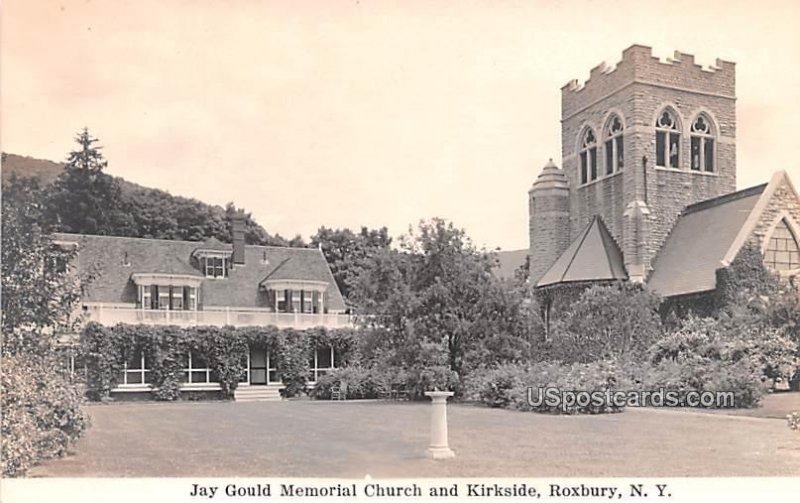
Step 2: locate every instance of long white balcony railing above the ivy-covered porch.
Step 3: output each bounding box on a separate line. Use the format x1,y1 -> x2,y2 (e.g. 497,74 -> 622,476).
86,304 -> 353,329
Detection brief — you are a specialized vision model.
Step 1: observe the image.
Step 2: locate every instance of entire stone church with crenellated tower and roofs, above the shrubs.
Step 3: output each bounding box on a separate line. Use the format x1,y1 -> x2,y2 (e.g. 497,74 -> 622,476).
528,45 -> 800,315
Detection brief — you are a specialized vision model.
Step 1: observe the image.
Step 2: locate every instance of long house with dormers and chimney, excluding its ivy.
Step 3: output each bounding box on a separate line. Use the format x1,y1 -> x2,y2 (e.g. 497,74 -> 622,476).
61,215 -> 351,402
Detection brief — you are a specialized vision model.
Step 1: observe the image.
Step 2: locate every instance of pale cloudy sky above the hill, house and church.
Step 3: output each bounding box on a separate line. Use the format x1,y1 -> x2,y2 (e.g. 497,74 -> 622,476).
0,0 -> 800,249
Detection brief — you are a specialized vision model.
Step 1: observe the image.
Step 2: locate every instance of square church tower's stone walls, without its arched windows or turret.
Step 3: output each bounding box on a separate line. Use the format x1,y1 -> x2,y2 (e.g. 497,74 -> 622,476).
562,46 -> 736,278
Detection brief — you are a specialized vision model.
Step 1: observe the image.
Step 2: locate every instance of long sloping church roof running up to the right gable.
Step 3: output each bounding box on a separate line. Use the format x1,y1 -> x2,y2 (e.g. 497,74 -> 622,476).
647,182 -> 772,297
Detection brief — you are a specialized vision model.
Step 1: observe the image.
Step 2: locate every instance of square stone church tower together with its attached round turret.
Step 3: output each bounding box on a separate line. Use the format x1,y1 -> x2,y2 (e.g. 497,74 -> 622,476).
529,45 -> 736,284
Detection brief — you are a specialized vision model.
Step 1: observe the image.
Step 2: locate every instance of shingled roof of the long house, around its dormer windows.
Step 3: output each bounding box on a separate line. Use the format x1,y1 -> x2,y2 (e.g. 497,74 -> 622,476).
54,233 -> 345,311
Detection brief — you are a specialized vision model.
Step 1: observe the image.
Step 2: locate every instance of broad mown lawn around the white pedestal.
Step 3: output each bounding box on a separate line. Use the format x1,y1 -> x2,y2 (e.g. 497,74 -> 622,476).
32,393 -> 800,477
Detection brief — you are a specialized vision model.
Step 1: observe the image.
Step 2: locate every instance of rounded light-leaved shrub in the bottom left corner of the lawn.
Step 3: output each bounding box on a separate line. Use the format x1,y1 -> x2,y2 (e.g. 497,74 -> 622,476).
0,355 -> 89,477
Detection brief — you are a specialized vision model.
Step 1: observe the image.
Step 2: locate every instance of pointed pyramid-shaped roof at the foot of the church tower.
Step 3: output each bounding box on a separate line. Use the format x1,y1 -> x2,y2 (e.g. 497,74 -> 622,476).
536,216 -> 628,287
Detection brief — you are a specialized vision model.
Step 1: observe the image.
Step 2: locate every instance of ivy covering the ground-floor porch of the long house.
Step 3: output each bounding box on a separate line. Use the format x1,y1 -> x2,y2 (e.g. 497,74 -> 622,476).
79,323 -> 358,400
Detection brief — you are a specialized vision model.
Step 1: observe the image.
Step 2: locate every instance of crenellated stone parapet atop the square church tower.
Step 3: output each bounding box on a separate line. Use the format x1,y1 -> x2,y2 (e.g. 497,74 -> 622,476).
561,45 -> 736,118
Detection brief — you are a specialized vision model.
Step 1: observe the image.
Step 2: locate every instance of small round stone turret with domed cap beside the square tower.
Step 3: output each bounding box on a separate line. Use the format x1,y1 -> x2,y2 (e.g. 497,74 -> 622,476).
528,159 -> 570,285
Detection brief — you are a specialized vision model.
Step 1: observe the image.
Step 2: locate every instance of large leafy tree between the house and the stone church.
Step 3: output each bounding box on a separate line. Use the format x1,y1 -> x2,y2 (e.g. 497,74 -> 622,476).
350,219 -> 531,375
